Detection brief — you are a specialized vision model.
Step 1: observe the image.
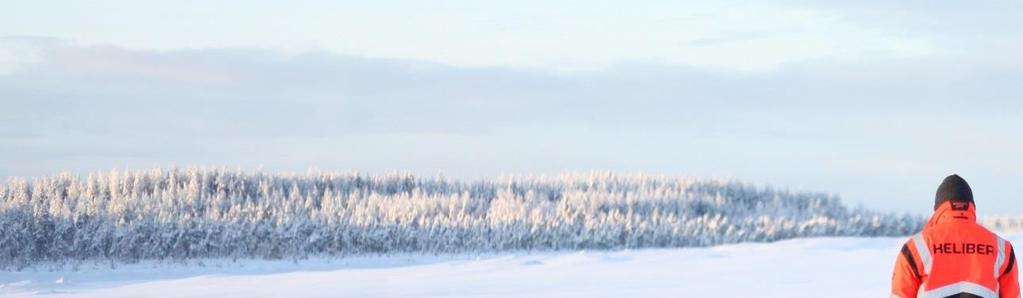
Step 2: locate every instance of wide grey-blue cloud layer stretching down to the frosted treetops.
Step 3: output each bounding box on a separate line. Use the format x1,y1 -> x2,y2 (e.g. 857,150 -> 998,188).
0,43 -> 1023,217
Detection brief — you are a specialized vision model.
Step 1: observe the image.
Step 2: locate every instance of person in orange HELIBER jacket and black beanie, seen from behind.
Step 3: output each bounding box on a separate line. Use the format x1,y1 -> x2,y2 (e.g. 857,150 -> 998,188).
891,175 -> 1020,298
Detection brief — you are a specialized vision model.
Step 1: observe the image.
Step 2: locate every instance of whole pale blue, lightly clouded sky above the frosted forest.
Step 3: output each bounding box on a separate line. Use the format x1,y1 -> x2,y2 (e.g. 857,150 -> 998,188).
0,0 -> 1023,214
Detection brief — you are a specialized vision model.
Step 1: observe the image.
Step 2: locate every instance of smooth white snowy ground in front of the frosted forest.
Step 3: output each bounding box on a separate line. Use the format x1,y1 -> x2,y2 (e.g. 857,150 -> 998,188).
0,235 -> 1023,298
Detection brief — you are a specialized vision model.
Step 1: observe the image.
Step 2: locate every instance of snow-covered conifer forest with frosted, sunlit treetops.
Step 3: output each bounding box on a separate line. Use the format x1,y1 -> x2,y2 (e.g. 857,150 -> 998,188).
0,168 -> 923,269
